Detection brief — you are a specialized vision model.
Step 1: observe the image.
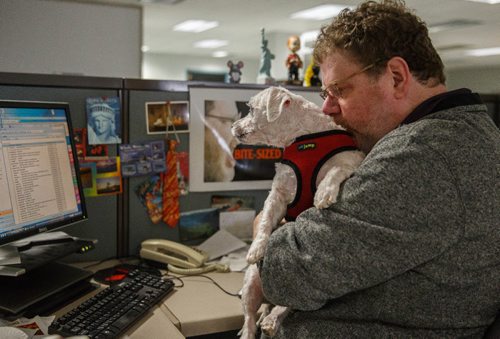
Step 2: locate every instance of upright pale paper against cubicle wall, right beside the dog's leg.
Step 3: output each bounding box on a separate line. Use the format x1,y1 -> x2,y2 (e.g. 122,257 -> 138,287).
219,210 -> 255,240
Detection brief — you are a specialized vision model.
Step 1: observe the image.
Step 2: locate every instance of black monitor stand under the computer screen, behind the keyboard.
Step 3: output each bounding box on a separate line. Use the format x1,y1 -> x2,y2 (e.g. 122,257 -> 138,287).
0,238 -> 95,317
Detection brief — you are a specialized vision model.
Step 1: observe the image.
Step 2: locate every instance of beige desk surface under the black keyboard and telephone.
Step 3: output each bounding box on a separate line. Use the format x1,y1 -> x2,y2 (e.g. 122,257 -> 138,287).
59,260 -> 244,339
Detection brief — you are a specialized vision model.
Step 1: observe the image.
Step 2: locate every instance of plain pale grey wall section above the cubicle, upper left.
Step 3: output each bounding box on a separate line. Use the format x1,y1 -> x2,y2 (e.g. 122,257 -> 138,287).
0,0 -> 142,77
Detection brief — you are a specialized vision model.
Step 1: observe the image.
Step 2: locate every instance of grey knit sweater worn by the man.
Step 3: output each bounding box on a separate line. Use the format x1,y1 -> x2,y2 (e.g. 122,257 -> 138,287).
261,100 -> 500,339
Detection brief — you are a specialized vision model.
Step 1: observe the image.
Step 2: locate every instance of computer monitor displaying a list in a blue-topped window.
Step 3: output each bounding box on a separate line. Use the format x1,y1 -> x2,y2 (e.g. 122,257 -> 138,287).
0,100 -> 87,245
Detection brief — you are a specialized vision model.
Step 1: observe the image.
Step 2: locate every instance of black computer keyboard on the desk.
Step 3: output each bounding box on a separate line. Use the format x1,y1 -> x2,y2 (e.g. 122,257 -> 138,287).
49,268 -> 174,339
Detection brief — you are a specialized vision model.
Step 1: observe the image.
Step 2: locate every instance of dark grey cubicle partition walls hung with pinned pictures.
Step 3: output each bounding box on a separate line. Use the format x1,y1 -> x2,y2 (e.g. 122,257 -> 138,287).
0,73 -> 500,261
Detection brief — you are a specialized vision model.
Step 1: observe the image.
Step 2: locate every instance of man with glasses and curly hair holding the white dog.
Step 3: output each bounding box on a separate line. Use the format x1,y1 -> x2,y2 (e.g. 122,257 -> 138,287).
259,1 -> 500,338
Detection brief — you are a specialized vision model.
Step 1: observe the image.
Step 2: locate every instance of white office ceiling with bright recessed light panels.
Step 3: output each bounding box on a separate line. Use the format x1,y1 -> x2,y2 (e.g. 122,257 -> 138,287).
72,0 -> 500,68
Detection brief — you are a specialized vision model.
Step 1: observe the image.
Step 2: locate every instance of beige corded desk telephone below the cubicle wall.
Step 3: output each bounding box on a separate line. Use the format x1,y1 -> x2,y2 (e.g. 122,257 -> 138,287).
140,239 -> 229,275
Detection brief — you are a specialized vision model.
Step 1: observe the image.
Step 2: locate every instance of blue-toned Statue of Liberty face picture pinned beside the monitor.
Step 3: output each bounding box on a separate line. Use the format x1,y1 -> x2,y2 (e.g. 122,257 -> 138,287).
86,97 -> 121,145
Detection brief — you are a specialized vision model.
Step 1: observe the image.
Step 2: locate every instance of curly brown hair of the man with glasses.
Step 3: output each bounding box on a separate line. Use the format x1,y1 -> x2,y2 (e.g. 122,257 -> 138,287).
313,0 -> 446,86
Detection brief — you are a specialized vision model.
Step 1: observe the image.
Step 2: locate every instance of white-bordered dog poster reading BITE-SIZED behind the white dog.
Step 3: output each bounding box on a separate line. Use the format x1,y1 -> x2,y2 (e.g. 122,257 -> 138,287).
189,86 -> 321,192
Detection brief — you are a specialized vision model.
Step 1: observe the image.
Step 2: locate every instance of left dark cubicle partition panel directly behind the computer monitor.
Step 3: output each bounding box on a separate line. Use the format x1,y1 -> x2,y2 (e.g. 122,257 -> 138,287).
0,73 -> 122,260
